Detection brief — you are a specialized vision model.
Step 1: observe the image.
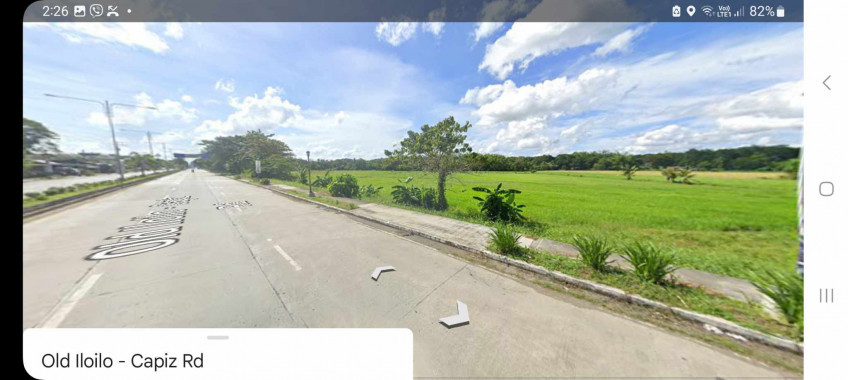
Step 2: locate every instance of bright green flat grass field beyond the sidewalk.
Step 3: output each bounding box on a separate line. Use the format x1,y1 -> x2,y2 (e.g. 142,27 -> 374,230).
287,171 -> 798,278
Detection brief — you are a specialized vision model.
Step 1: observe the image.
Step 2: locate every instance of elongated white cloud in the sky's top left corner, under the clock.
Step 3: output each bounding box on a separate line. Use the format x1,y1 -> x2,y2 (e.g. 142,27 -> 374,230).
24,22 -> 169,54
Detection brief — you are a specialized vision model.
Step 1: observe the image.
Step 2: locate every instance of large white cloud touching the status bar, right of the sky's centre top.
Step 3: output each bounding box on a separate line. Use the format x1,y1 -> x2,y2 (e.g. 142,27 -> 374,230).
478,22 -> 627,80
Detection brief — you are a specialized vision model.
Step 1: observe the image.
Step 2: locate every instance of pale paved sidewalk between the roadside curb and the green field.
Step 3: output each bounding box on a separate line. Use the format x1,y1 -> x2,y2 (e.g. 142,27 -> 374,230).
272,185 -> 773,309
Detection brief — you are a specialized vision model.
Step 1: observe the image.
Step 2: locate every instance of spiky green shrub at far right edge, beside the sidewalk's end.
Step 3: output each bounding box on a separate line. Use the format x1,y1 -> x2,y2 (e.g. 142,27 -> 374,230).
752,271 -> 804,326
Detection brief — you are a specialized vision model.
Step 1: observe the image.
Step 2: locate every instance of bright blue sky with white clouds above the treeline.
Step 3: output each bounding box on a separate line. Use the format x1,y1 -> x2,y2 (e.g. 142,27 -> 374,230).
23,23 -> 803,158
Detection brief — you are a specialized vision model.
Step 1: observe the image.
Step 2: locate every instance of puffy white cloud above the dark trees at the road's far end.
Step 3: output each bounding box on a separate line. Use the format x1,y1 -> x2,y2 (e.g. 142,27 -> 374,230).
194,87 -> 303,141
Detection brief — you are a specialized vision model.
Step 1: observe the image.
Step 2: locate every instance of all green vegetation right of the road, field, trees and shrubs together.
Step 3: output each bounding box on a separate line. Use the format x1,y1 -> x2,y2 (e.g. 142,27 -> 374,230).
198,117 -> 803,338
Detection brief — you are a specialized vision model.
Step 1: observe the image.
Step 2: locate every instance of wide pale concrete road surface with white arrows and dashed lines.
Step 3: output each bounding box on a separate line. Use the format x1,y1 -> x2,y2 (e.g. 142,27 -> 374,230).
23,171 -> 780,378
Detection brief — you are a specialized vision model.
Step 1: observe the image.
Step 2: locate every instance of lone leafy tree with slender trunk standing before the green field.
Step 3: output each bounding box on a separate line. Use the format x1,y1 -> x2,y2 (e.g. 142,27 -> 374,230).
385,116 -> 471,210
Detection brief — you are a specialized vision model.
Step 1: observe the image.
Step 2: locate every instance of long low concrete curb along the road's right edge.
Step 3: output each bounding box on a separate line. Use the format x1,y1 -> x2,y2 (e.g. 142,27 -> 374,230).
238,180 -> 804,354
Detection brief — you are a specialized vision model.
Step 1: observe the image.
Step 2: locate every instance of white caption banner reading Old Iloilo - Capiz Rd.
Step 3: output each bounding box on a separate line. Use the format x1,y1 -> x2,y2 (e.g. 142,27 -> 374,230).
23,328 -> 412,379
